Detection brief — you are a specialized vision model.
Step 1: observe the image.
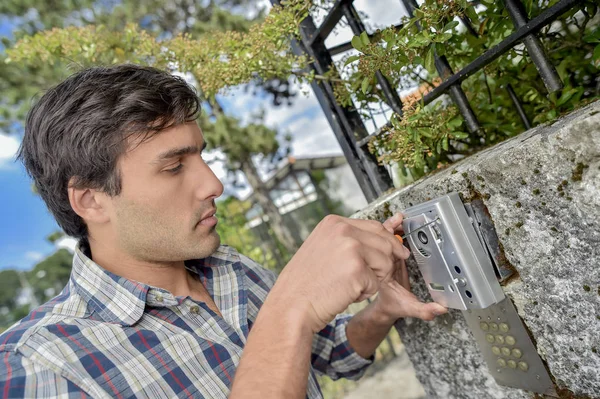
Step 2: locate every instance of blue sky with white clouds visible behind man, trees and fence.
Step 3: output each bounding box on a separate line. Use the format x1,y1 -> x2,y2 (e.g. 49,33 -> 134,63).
0,0 -> 404,270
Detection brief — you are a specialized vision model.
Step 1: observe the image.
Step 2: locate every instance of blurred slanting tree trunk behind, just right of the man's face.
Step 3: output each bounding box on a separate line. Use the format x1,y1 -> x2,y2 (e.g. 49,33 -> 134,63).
242,159 -> 298,255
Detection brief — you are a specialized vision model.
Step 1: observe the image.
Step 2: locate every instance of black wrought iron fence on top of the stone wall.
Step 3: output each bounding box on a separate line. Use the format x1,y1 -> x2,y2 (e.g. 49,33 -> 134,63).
271,0 -> 582,201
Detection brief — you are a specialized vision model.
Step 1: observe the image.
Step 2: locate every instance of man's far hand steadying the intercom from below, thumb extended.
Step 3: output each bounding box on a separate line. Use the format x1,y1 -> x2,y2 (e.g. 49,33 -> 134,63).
371,213 -> 448,322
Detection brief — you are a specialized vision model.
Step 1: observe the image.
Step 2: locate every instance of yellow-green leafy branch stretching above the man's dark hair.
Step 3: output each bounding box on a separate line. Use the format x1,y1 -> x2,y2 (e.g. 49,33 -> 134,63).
5,2 -> 308,98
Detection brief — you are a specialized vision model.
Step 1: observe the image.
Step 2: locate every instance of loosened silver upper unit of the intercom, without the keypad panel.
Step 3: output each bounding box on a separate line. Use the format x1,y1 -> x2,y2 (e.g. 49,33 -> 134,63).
403,193 -> 504,310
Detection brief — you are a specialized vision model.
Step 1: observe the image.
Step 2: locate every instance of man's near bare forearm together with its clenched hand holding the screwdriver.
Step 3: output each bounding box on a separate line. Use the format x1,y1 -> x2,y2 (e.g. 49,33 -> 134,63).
230,215 -> 410,399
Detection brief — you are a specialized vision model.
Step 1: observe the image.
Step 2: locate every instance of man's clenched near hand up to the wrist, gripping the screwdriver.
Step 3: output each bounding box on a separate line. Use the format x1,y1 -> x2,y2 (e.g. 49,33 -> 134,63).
267,215 -> 410,333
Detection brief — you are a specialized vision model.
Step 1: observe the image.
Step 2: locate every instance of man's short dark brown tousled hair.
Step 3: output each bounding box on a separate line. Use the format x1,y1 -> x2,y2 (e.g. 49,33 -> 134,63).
18,64 -> 200,242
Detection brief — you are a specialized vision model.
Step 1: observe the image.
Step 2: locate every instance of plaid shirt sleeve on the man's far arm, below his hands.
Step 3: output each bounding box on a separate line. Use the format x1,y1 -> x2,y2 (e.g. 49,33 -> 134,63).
311,315 -> 375,380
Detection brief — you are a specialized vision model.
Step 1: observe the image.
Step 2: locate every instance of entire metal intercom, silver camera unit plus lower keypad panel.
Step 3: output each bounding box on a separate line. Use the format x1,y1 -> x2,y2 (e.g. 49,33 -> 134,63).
403,193 -> 556,396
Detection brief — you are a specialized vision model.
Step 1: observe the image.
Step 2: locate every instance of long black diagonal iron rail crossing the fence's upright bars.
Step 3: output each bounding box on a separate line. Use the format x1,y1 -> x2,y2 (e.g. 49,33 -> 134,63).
423,0 -> 582,105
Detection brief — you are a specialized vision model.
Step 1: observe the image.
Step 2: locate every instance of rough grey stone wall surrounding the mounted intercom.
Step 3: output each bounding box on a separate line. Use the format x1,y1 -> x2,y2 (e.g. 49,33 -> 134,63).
354,102 -> 600,398
